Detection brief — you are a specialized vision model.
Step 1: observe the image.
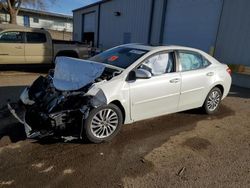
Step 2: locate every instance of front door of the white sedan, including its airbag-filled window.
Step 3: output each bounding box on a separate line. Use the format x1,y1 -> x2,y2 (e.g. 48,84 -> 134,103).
129,52 -> 181,121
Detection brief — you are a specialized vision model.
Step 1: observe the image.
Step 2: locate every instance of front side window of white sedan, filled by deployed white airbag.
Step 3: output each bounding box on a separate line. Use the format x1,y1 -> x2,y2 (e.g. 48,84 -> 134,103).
140,53 -> 175,76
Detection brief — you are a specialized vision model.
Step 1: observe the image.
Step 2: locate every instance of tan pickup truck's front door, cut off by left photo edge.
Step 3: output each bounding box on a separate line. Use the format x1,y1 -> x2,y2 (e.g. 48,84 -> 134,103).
0,31 -> 25,64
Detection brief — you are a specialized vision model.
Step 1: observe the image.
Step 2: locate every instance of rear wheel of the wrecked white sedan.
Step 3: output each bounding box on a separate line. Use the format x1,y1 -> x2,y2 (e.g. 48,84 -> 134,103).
202,87 -> 222,115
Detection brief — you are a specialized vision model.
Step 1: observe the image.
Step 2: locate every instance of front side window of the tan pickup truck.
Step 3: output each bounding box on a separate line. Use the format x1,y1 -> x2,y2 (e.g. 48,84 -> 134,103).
0,31 -> 23,43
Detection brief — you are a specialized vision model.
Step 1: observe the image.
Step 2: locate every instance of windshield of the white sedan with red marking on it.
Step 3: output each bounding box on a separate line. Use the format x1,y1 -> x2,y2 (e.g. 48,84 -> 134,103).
89,47 -> 148,69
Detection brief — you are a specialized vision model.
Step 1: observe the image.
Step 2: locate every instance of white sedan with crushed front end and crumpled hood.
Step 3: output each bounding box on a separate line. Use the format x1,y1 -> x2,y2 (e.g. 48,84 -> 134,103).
9,44 -> 231,143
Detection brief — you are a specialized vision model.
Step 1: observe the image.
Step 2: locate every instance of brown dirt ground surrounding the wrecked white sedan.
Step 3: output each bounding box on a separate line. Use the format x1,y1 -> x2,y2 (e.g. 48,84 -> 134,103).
0,72 -> 250,187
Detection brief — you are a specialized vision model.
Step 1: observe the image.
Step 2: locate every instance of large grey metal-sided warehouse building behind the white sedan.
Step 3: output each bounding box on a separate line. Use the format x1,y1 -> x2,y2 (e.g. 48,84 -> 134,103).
73,0 -> 250,62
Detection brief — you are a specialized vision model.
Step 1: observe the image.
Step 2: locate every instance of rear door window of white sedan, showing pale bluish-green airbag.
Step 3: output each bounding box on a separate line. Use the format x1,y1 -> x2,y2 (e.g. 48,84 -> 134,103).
179,52 -> 204,71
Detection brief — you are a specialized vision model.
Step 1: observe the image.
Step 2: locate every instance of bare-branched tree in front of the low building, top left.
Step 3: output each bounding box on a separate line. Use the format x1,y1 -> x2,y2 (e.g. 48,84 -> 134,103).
0,0 -> 55,24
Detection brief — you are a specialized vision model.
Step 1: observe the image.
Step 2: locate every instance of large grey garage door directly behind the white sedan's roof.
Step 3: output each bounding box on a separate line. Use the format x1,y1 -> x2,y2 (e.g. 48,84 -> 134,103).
163,0 -> 223,52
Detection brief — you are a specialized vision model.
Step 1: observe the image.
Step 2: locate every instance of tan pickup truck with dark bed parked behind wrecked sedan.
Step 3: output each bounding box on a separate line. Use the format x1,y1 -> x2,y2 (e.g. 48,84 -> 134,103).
0,24 -> 90,65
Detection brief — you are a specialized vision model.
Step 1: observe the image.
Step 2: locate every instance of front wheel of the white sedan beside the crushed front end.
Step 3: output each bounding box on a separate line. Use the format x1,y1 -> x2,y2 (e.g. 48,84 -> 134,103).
83,104 -> 123,143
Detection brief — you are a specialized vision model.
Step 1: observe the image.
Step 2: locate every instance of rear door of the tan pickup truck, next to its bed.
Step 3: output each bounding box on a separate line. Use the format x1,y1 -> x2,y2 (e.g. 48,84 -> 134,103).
25,32 -> 52,64
